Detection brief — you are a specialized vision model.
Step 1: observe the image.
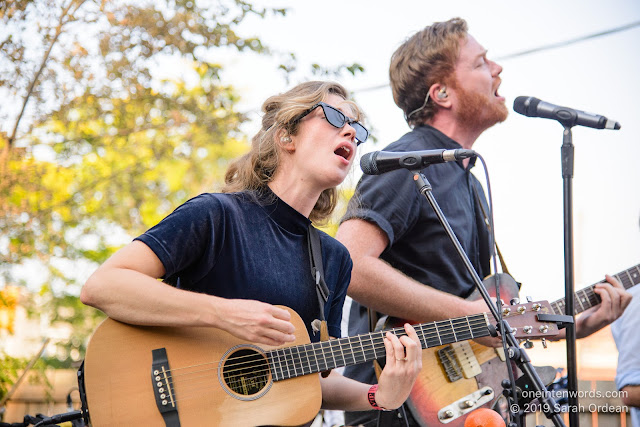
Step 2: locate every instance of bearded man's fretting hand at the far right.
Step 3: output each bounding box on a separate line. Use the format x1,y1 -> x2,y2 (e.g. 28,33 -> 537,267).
576,275 -> 632,338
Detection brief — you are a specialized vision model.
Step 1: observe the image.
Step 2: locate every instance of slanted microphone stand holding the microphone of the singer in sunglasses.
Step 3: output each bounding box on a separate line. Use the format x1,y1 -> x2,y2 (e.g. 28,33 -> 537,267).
411,170 -> 565,427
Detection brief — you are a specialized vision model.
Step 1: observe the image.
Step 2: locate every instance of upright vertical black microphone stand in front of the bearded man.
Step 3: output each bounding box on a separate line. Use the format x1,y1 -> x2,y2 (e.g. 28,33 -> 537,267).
560,124 -> 580,427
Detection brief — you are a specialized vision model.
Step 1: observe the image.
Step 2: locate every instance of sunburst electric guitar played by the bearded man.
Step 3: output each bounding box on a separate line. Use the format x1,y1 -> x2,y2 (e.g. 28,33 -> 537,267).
402,264 -> 640,426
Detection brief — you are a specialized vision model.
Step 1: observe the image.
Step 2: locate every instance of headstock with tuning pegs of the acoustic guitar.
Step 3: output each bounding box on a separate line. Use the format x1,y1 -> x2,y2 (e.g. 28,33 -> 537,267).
502,301 -> 559,339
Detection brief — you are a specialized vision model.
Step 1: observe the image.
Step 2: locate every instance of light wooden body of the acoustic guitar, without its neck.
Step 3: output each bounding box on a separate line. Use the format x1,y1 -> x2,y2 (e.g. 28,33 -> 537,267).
85,312 -> 322,427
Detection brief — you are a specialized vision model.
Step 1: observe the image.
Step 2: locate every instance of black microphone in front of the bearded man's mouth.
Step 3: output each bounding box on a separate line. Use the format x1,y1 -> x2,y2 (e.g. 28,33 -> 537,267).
513,96 -> 620,130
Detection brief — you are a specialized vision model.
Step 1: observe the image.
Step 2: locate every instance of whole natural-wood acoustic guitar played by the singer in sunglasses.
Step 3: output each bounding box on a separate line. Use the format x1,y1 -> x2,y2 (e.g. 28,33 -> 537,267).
84,302 -> 558,427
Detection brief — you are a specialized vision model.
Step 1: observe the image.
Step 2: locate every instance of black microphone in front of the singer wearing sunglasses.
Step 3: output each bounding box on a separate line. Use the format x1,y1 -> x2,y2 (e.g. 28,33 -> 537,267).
360,148 -> 476,175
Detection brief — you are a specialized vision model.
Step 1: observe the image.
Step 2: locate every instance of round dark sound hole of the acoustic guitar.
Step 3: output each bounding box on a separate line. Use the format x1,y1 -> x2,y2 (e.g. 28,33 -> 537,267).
222,348 -> 269,396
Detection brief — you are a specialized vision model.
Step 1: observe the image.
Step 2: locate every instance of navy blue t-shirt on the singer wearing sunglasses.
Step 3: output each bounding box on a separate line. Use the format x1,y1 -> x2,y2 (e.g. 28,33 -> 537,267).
136,190 -> 352,341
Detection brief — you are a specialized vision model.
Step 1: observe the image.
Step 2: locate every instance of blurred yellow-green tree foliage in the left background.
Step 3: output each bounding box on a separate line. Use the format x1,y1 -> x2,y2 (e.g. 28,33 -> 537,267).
0,0 -> 363,404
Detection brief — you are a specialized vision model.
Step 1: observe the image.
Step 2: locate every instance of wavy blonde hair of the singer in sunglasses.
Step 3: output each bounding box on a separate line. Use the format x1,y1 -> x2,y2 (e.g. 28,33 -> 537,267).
222,81 -> 363,222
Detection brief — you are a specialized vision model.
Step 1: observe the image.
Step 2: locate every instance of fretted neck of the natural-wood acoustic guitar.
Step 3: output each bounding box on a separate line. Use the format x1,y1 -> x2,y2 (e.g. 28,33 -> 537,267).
267,313 -> 489,381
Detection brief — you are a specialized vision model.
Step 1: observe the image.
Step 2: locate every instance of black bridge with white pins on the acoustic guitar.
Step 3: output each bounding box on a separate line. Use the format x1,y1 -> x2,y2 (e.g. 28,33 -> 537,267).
151,348 -> 180,427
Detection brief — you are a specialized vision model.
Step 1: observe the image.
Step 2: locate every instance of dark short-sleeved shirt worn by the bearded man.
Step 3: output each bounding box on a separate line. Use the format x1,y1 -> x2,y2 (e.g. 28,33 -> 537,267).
342,126 -> 490,382
